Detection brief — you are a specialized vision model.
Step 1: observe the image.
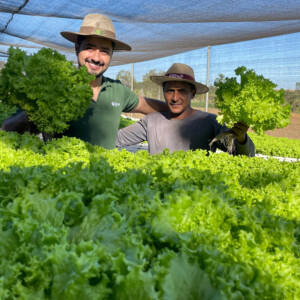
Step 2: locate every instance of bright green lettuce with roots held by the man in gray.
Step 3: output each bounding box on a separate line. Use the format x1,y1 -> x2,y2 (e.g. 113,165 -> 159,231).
214,66 -> 291,134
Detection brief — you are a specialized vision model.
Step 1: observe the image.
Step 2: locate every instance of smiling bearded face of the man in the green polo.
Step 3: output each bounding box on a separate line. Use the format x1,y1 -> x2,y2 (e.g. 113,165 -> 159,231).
75,36 -> 113,78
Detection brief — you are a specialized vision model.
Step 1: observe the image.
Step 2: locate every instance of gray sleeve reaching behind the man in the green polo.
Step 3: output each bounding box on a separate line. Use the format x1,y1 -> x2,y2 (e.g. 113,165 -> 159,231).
116,119 -> 147,147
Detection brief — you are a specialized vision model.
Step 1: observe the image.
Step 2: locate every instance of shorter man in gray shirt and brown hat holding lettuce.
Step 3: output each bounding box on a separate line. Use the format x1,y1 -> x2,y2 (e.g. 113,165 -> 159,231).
116,63 -> 255,156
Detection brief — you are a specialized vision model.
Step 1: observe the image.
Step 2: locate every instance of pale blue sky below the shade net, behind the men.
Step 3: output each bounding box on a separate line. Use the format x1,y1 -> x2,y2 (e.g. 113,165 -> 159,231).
105,33 -> 300,89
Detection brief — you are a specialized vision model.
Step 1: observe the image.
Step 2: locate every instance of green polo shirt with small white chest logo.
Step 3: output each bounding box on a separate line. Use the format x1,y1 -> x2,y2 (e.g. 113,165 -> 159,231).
63,76 -> 139,149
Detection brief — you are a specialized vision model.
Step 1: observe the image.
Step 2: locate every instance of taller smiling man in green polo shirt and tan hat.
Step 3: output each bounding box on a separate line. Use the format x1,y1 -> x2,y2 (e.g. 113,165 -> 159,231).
2,14 -> 167,149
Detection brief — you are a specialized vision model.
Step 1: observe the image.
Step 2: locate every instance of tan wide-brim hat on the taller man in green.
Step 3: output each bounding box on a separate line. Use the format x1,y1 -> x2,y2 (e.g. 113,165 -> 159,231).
60,14 -> 131,51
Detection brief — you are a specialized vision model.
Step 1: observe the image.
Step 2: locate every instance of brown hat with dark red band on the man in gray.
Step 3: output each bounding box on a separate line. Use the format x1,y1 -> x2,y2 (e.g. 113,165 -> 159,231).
150,63 -> 209,94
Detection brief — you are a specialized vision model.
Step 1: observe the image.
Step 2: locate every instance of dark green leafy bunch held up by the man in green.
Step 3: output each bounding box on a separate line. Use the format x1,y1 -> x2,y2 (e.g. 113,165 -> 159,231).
0,47 -> 94,134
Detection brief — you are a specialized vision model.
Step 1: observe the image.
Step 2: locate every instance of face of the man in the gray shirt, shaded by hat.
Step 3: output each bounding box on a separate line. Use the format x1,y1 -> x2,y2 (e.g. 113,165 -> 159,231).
164,81 -> 196,119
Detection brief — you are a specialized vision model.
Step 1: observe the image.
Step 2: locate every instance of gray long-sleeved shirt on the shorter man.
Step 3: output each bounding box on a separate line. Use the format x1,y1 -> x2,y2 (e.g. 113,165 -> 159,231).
116,110 -> 255,156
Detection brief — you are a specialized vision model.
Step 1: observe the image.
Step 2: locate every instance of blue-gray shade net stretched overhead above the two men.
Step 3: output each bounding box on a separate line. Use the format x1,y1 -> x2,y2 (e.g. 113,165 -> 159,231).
0,0 -> 300,65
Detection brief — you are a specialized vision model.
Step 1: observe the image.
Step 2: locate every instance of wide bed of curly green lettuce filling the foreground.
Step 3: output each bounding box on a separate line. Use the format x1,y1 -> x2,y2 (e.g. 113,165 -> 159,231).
0,131 -> 300,300
